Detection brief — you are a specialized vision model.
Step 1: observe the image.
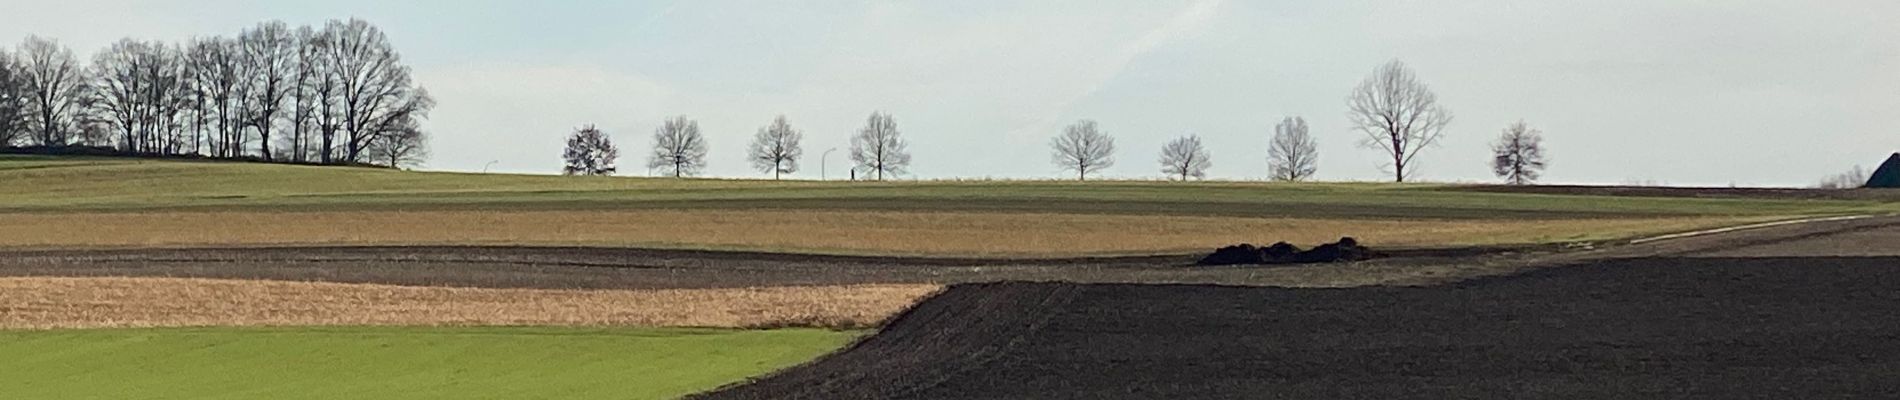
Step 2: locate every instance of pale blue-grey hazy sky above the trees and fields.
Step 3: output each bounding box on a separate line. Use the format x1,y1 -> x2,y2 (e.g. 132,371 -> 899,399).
0,0 -> 1900,186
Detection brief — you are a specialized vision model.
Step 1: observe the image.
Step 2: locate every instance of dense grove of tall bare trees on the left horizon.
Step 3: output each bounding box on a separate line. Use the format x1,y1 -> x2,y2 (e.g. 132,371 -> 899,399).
0,19 -> 435,167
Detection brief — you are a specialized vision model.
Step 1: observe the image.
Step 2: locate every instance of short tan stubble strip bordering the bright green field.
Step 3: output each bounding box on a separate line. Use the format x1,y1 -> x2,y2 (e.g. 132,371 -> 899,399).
0,277 -> 941,330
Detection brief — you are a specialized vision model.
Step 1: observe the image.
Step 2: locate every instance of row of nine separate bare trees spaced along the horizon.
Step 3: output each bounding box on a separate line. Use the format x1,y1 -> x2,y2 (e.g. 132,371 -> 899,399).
562,61 -> 1547,184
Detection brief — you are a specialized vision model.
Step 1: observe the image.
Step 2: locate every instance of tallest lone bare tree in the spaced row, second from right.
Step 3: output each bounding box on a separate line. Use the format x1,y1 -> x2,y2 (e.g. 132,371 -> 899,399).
1347,61 -> 1452,182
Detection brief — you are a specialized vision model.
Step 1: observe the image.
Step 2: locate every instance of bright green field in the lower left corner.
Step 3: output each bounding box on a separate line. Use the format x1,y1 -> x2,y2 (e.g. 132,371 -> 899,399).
0,328 -> 859,400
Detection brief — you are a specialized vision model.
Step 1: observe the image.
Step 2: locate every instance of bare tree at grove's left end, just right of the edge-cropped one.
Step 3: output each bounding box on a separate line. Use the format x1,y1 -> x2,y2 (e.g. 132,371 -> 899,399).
15,36 -> 86,146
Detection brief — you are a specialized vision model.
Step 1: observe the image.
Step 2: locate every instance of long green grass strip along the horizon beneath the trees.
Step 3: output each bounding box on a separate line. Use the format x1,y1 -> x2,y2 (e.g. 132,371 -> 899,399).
0,155 -> 1900,218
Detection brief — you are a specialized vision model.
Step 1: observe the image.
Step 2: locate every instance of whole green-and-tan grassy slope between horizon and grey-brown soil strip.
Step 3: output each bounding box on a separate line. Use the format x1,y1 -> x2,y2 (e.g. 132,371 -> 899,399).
0,155 -> 1900,256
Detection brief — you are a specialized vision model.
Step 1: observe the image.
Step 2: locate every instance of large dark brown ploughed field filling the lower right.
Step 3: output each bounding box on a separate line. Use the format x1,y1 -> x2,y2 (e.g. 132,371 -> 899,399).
701,220 -> 1900,400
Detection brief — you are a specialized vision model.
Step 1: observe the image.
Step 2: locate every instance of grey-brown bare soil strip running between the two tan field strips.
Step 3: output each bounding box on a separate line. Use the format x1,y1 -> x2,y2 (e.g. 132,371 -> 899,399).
0,218 -> 1900,290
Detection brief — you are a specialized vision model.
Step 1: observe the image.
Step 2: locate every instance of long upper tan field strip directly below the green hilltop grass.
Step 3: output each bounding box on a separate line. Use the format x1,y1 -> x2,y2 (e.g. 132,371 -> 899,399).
0,210 -> 1765,256
